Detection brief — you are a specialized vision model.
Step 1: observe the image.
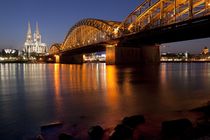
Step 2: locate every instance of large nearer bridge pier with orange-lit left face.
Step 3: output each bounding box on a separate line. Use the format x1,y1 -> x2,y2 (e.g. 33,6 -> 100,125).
106,45 -> 160,65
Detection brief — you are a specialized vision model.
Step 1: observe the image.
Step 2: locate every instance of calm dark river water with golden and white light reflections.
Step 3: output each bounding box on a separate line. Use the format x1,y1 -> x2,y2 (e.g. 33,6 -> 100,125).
0,63 -> 210,140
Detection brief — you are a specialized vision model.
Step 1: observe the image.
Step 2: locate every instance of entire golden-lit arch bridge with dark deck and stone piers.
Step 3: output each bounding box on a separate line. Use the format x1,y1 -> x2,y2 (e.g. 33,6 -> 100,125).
49,0 -> 210,64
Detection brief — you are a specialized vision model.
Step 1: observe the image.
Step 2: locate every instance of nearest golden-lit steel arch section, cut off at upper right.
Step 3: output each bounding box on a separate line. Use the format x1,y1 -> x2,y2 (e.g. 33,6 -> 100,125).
119,0 -> 210,35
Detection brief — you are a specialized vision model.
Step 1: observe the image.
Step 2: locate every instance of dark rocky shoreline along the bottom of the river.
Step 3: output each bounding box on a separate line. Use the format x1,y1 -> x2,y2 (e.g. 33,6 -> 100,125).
34,103 -> 210,140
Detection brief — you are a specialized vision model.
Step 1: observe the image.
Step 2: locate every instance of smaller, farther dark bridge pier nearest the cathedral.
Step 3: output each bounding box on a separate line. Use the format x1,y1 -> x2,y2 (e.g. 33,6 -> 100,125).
60,54 -> 83,64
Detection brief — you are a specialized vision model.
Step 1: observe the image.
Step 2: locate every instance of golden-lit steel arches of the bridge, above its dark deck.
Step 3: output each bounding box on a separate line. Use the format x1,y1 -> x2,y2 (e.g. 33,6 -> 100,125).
49,0 -> 210,54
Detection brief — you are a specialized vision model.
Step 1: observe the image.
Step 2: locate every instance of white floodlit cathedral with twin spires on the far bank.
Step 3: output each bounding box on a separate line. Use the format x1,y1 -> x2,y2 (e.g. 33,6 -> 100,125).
23,23 -> 47,55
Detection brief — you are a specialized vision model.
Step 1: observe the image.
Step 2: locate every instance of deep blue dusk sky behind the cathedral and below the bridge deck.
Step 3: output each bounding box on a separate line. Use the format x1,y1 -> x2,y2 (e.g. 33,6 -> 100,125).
0,0 -> 210,53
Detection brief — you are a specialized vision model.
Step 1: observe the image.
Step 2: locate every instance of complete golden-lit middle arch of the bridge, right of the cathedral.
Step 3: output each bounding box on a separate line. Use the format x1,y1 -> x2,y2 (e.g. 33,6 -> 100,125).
60,19 -> 120,51
